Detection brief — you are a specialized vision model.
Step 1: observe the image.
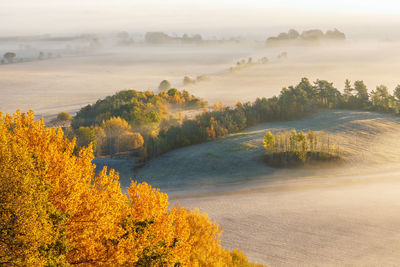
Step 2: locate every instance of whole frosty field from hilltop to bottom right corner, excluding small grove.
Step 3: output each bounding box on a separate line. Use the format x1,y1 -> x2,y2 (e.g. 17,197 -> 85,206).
134,110 -> 400,266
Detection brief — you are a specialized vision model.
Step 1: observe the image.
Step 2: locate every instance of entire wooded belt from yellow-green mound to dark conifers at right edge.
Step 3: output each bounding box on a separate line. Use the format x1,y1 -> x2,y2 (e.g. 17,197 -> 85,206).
66,78 -> 400,162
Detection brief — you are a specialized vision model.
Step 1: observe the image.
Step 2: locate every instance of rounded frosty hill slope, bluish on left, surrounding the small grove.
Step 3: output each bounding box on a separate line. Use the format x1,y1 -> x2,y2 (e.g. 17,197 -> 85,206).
135,110 -> 400,196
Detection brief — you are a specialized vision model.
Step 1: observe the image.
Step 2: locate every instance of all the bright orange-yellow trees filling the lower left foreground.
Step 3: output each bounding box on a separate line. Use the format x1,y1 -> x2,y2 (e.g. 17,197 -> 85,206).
0,111 -> 262,266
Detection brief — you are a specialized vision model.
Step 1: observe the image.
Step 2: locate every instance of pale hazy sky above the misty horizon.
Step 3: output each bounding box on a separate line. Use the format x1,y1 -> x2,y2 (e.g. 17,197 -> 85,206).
0,0 -> 400,37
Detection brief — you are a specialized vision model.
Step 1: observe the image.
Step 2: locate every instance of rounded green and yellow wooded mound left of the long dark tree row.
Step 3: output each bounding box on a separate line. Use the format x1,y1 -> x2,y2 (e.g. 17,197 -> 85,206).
69,88 -> 208,155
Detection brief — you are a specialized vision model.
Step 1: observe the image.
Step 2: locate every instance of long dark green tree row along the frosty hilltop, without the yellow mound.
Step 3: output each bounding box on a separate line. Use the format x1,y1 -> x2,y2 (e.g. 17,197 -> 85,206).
141,78 -> 400,161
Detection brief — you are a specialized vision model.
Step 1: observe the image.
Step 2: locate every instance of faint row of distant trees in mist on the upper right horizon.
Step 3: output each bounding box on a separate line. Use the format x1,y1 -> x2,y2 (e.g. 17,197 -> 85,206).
266,29 -> 346,45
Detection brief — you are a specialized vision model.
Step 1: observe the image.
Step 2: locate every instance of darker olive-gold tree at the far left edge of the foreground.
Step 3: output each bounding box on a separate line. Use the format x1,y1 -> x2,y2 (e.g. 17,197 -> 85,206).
0,113 -> 66,266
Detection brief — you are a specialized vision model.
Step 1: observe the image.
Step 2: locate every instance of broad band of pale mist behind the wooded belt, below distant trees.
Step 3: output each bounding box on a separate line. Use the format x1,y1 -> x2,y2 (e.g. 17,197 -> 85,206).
0,41 -> 400,116
